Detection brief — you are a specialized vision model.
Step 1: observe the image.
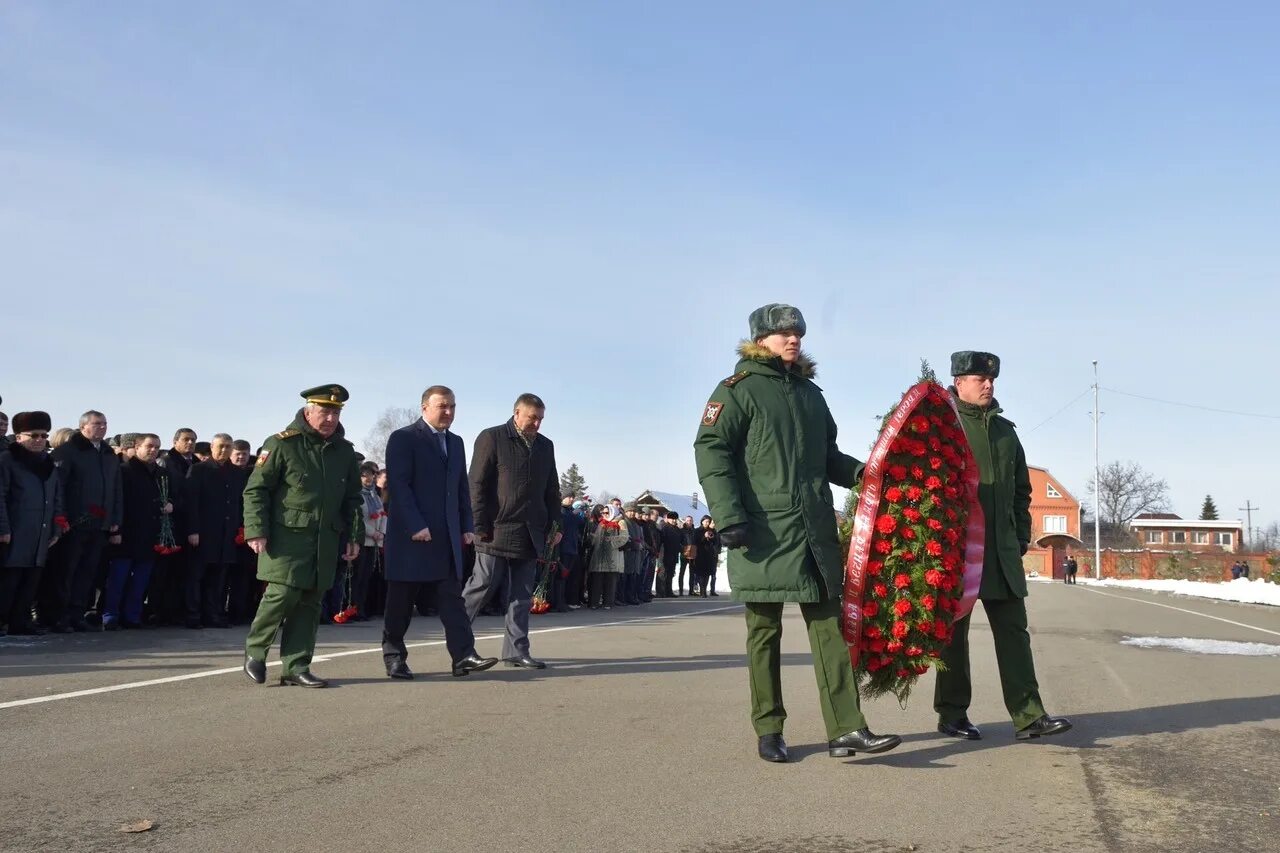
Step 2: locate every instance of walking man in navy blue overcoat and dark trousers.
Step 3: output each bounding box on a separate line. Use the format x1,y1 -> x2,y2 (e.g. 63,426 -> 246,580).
383,386 -> 498,679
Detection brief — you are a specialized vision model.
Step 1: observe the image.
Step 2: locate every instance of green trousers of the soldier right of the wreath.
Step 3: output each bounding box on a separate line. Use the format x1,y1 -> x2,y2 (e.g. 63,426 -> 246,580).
933,598 -> 1044,729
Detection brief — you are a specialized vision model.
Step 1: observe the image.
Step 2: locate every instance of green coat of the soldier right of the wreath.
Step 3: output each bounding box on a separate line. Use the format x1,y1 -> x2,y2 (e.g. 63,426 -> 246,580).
952,389 -> 1032,598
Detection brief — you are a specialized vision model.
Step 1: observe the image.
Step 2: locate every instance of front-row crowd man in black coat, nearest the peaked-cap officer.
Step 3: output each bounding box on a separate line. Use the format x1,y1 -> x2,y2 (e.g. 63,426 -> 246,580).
183,433 -> 250,628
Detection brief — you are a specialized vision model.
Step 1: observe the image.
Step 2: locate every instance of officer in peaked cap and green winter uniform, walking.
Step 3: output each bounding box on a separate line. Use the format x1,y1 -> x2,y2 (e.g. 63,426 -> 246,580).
244,384 -> 365,688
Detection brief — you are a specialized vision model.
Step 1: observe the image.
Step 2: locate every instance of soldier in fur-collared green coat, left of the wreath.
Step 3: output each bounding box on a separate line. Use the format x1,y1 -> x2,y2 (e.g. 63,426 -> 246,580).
694,304 -> 901,762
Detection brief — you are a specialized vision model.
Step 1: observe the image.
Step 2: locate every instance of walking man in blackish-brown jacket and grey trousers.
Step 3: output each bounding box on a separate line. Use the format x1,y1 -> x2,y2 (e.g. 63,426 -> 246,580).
463,394 -> 561,670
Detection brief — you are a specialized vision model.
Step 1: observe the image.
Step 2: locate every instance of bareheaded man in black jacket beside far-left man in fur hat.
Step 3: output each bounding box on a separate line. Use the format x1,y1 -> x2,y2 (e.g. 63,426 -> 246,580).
40,411 -> 123,634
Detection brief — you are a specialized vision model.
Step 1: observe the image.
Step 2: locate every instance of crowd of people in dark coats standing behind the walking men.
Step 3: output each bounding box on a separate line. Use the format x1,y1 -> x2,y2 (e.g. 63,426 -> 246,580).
0,411 -> 721,635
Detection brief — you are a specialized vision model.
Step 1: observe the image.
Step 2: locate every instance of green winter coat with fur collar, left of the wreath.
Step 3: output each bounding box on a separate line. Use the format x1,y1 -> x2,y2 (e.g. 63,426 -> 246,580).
694,341 -> 861,603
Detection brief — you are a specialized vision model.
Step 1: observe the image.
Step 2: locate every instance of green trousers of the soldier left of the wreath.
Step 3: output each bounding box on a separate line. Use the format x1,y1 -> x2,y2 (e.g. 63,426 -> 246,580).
746,599 -> 867,740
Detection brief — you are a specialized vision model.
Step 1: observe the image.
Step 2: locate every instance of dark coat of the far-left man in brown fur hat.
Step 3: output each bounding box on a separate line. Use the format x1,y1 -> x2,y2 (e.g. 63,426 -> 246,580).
0,442 -> 63,569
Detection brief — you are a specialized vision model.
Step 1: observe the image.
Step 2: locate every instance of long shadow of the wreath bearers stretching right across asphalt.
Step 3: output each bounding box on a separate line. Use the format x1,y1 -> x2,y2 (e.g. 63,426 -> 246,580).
849,695 -> 1280,768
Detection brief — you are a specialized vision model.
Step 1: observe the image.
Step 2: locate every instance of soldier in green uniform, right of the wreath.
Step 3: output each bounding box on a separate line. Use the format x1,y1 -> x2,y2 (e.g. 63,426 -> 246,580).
933,351 -> 1071,740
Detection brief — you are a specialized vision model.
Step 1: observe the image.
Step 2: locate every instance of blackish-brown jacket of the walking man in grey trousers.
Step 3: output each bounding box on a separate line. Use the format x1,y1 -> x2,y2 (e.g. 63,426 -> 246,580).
465,419 -> 562,560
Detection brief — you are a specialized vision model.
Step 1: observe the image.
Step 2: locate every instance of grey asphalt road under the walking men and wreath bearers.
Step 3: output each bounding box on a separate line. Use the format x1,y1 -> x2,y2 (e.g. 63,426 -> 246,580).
0,584 -> 1280,853
